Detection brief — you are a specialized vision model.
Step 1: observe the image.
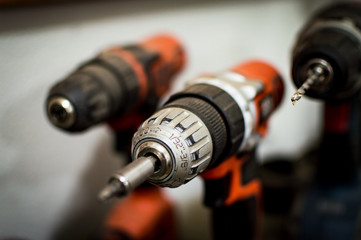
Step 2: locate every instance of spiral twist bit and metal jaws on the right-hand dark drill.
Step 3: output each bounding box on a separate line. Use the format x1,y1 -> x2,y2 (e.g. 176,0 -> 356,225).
291,64 -> 328,106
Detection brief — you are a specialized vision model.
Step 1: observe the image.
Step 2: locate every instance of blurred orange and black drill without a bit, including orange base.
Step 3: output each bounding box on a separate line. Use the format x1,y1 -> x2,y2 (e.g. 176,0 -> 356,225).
46,35 -> 185,239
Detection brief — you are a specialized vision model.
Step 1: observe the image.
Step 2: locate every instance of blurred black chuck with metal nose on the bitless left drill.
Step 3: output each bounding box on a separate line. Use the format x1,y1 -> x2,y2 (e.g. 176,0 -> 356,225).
47,64 -> 118,132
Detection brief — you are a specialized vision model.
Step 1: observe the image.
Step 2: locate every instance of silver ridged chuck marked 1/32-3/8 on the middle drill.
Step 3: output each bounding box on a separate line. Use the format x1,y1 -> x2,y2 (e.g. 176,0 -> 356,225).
132,107 -> 213,187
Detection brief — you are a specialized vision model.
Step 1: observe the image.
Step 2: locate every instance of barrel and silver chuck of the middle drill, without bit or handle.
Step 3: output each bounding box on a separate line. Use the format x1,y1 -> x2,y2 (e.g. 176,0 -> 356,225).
128,62 -> 283,187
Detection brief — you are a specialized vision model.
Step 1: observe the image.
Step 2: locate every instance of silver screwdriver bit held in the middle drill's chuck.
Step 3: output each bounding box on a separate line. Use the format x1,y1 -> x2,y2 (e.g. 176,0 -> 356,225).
99,156 -> 158,201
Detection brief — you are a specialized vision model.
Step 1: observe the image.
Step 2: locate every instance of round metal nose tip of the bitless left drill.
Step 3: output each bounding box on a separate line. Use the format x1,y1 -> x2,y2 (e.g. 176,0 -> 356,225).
47,97 -> 75,129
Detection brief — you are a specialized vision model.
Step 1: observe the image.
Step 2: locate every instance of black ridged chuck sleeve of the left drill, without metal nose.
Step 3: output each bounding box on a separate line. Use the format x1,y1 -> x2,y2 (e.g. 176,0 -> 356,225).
48,64 -> 121,132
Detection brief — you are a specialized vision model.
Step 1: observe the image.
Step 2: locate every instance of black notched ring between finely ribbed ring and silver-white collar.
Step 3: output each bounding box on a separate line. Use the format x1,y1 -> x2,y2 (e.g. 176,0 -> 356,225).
168,84 -> 245,167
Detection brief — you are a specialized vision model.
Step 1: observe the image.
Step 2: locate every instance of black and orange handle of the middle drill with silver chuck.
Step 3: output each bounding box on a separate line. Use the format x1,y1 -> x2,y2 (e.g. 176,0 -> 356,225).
202,151 -> 262,240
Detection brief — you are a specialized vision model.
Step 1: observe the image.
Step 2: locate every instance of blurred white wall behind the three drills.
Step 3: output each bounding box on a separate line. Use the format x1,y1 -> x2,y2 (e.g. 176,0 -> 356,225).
0,0 -> 327,240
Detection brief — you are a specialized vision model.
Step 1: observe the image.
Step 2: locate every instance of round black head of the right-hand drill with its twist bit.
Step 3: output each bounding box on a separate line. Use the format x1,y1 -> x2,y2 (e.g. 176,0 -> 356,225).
291,2 -> 361,101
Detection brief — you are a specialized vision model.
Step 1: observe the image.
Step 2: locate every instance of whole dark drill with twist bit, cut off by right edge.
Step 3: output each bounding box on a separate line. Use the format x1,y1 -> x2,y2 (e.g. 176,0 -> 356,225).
291,1 -> 361,240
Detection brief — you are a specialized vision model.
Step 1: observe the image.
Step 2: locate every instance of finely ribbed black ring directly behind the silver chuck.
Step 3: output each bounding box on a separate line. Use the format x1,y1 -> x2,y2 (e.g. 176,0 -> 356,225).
164,97 -> 227,164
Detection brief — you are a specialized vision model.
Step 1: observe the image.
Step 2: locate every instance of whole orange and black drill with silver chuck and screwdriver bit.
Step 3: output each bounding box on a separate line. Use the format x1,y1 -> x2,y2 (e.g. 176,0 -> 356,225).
99,61 -> 283,238
